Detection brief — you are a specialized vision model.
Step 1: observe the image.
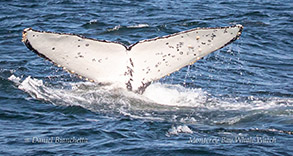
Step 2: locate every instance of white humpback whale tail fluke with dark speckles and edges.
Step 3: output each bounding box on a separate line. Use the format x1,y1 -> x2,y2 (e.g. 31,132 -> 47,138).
22,25 -> 243,93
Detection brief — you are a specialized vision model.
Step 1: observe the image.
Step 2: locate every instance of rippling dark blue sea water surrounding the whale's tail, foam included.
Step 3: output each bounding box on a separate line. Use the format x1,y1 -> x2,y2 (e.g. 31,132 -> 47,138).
0,0 -> 293,155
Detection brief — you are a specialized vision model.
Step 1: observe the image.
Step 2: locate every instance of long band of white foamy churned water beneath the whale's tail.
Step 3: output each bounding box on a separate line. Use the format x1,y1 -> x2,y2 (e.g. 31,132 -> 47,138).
8,75 -> 293,125
